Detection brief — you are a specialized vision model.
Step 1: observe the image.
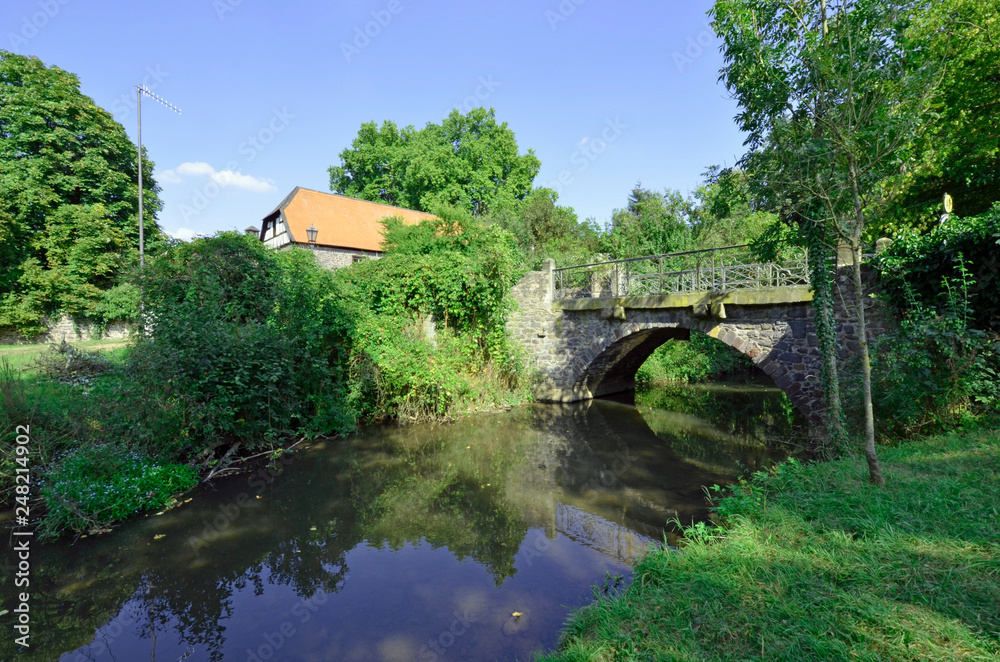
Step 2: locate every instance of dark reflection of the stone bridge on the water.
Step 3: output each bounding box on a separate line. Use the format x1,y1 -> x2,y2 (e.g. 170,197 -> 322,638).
506,400 -> 788,564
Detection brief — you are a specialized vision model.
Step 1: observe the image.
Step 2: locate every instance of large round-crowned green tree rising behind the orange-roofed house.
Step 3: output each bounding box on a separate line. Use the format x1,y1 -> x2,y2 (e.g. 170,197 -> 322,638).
329,108 -> 541,216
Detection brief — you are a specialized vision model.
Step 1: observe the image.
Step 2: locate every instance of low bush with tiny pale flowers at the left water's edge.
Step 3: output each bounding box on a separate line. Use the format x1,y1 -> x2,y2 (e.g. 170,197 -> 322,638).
39,444 -> 198,538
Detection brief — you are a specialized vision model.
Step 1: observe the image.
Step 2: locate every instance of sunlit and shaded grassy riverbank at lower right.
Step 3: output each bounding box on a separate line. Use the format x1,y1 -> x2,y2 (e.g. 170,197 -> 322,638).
544,430 -> 1000,662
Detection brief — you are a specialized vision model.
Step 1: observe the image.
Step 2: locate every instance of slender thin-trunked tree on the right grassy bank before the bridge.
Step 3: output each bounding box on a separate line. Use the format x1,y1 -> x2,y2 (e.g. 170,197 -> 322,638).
712,0 -> 937,485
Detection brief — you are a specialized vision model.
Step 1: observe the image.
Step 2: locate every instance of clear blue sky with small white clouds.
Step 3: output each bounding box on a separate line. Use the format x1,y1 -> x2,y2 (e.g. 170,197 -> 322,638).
0,0 -> 743,243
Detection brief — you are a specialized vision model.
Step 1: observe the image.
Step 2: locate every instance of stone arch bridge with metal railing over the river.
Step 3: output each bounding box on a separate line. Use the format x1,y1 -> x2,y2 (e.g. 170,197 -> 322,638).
507,246 -> 888,430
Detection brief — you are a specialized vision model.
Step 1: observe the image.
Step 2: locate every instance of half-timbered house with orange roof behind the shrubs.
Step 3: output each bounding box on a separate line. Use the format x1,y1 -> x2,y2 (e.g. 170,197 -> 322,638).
258,186 -> 435,269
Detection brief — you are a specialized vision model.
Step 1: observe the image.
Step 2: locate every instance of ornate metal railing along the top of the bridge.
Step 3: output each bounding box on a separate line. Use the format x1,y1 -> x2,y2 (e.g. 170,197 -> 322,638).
553,244 -> 809,300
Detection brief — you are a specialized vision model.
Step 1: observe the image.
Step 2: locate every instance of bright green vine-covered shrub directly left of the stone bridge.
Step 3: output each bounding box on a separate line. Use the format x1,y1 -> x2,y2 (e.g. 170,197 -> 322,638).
338,210 -> 525,420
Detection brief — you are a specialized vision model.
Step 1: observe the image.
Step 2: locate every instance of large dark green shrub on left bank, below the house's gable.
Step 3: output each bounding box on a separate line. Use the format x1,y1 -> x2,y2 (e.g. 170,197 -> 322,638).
127,233 -> 353,458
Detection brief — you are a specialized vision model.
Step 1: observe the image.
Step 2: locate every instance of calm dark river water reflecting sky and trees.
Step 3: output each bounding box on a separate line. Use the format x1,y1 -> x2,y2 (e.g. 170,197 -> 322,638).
0,384 -> 804,662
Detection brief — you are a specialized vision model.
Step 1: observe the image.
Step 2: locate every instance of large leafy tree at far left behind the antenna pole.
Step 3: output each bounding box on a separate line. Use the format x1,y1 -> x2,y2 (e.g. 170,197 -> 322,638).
0,51 -> 163,334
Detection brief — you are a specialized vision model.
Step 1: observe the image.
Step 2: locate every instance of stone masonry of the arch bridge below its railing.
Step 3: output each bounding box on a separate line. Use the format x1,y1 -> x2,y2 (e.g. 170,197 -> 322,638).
507,260 -> 887,424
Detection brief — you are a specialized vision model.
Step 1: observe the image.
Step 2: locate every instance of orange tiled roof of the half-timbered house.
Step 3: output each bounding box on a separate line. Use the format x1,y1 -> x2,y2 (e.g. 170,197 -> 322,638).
264,186 -> 435,251
